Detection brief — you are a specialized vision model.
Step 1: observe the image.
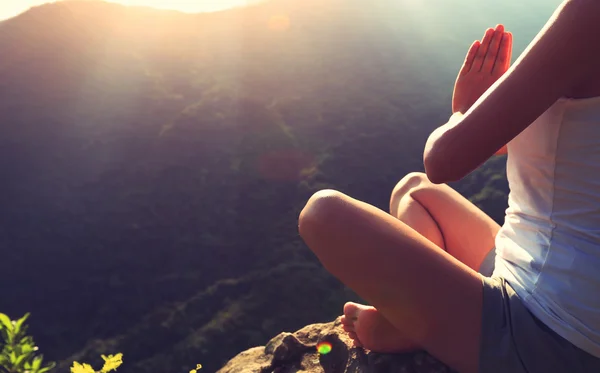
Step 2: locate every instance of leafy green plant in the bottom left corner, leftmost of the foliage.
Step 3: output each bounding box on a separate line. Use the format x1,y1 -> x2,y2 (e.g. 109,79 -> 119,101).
0,313 -> 56,373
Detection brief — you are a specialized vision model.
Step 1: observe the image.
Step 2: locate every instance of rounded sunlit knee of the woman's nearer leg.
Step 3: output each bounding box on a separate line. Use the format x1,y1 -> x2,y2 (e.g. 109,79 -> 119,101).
298,189 -> 347,241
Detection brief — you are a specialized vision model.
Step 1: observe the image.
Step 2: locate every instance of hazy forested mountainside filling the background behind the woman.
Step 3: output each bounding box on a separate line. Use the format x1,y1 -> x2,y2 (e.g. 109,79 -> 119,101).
0,0 -> 558,372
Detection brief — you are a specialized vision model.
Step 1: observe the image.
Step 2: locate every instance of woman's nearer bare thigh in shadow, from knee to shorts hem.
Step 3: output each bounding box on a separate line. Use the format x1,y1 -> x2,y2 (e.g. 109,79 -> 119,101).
299,191 -> 482,373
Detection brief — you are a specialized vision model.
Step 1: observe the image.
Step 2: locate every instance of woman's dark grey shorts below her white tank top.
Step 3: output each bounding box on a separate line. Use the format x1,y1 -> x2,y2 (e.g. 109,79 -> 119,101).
479,249 -> 600,373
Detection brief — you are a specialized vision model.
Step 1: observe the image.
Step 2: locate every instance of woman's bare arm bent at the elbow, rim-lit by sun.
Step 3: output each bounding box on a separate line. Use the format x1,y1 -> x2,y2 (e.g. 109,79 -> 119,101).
423,0 -> 600,184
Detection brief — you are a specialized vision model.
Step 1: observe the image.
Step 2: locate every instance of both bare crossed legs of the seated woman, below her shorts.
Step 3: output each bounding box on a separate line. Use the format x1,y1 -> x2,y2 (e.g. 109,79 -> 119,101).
299,173 -> 499,373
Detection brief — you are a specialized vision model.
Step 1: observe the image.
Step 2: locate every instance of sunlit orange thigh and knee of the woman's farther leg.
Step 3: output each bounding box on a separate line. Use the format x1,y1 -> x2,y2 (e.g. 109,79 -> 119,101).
390,172 -> 500,270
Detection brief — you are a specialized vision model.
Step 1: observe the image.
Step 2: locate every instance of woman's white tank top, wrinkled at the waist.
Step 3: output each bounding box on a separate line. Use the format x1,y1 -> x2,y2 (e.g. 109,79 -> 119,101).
494,97 -> 600,357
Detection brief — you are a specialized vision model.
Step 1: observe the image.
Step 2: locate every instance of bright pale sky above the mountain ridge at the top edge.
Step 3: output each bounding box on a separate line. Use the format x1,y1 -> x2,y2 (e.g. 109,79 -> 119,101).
0,0 -> 258,20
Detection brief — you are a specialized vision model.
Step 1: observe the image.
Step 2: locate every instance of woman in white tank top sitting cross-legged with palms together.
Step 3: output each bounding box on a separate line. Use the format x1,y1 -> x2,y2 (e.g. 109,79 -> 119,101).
299,0 -> 600,373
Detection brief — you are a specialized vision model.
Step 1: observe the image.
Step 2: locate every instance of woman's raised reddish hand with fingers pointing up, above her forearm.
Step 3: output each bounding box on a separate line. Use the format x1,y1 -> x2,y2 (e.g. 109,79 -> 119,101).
452,25 -> 512,114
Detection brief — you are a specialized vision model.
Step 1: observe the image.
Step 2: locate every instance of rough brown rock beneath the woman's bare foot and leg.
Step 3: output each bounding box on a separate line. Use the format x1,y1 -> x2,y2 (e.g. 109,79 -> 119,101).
217,318 -> 453,373
